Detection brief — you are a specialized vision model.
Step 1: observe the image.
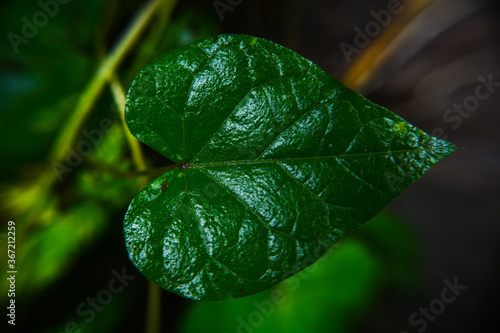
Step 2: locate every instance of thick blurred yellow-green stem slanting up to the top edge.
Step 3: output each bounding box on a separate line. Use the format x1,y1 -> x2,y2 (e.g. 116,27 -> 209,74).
49,0 -> 163,161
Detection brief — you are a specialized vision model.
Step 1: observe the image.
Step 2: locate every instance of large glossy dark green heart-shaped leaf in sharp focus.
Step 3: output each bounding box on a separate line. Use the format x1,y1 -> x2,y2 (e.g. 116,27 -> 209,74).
124,35 -> 455,300
